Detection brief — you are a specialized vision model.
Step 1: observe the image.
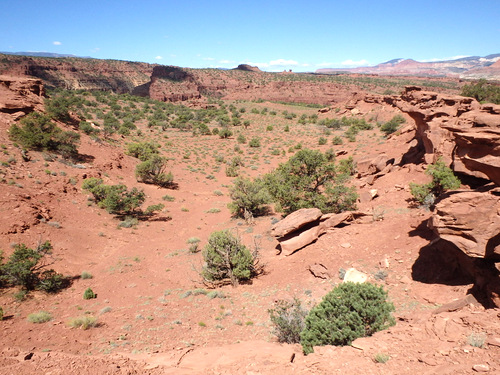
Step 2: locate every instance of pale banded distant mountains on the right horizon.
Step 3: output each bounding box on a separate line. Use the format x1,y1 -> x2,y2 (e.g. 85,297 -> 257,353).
316,53 -> 500,80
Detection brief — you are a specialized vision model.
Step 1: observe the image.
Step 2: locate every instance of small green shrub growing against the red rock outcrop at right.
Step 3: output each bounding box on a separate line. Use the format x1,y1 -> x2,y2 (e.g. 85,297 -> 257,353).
410,159 -> 460,206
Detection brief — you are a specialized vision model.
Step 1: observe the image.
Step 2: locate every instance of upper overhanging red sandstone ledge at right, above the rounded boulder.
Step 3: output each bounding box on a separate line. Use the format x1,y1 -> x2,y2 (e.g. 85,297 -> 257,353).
393,87 -> 500,185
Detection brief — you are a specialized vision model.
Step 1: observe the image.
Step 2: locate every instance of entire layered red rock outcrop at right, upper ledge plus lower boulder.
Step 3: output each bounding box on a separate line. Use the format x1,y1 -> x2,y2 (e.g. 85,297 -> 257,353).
385,87 -> 500,307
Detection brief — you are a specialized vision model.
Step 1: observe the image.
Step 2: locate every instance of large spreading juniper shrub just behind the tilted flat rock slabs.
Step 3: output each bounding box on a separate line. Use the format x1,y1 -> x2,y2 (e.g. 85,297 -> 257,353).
264,149 -> 357,214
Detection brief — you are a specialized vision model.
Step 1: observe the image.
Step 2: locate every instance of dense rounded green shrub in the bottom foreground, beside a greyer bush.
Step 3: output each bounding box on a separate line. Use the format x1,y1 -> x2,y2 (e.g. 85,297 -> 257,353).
300,282 -> 395,354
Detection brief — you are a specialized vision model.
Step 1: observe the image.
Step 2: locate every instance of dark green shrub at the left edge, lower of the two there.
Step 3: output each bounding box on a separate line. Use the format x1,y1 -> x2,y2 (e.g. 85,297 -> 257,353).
0,241 -> 69,293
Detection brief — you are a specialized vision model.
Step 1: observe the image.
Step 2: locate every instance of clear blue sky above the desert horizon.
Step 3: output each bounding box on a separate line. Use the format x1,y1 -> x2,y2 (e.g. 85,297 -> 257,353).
0,0 -> 500,71
